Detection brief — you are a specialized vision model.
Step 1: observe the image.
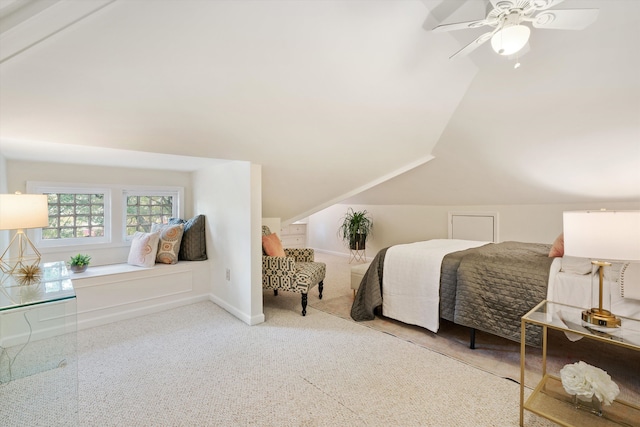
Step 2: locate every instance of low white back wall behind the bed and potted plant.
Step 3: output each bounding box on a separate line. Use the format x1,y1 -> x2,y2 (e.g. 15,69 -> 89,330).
308,202 -> 640,258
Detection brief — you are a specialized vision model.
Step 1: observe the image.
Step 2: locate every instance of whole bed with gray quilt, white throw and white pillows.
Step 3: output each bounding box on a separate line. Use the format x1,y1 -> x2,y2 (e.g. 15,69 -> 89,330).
351,239 -> 640,348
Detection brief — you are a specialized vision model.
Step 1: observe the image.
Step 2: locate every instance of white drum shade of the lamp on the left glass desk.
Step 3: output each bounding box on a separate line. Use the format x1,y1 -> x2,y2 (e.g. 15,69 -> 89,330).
0,194 -> 49,230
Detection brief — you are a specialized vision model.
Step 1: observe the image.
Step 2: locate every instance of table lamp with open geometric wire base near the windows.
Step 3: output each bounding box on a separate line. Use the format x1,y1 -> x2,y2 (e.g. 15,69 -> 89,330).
0,192 -> 49,275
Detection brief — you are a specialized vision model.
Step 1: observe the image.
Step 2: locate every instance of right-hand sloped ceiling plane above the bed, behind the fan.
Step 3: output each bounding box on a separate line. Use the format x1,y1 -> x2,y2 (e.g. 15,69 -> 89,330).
346,0 -> 640,207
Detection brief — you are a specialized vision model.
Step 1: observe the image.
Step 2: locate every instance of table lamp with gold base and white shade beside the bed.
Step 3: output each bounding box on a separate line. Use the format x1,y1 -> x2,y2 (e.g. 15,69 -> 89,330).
563,210 -> 640,328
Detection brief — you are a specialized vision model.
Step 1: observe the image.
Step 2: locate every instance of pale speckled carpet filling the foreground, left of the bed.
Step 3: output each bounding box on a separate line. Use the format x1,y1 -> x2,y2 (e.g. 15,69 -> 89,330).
0,300 -> 551,427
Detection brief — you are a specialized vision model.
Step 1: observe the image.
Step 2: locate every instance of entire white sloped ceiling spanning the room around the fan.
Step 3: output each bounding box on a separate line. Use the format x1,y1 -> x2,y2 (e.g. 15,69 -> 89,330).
0,0 -> 640,221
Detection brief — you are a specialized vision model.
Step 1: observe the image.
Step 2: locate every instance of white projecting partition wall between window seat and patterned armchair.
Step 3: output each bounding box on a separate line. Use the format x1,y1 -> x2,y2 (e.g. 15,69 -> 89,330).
193,161 -> 264,325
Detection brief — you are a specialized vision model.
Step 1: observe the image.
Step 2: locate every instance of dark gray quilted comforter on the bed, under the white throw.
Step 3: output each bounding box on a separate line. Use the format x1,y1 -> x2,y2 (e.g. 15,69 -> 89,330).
351,242 -> 553,345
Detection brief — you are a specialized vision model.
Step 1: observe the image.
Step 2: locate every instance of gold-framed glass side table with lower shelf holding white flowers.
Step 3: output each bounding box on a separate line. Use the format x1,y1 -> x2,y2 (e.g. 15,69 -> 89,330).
520,301 -> 640,426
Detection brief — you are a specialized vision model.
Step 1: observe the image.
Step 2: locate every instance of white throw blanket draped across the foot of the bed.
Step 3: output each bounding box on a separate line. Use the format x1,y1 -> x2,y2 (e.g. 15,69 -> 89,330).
382,239 -> 490,332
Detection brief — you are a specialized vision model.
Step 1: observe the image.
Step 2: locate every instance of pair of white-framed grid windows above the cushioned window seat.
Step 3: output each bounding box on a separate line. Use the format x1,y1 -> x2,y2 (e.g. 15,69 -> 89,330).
27,182 -> 184,248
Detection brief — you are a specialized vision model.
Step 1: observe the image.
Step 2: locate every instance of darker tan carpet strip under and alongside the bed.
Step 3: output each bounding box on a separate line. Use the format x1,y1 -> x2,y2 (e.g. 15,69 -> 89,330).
309,252 -> 640,408
